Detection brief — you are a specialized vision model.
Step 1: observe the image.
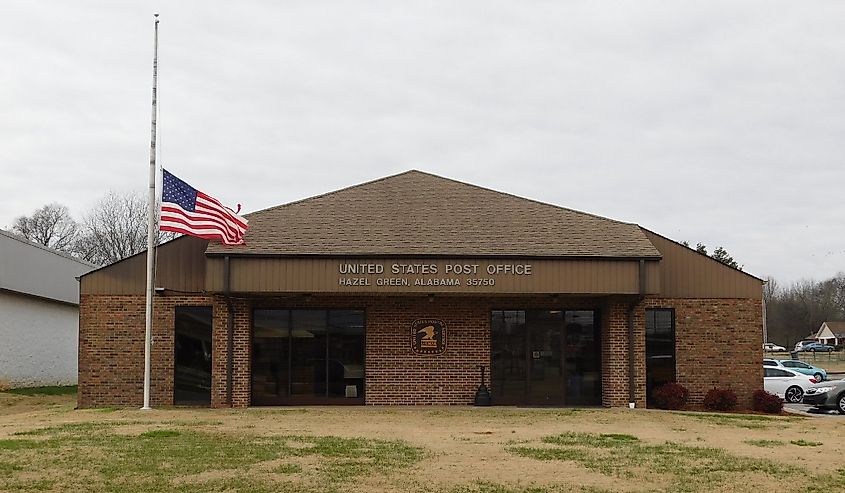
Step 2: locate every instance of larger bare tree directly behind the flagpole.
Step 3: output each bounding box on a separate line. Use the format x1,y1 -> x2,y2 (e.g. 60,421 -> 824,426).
74,192 -> 178,265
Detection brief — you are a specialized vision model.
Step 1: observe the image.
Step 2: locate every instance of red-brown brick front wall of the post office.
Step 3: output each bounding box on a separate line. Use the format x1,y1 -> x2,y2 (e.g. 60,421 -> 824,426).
79,293 -> 762,407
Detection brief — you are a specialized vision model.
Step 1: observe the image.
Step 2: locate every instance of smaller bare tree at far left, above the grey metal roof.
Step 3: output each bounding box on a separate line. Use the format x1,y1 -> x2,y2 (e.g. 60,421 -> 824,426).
12,202 -> 79,252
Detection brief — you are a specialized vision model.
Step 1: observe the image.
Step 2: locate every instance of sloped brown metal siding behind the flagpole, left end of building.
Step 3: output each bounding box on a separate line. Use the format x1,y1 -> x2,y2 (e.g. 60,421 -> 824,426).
79,236 -> 208,295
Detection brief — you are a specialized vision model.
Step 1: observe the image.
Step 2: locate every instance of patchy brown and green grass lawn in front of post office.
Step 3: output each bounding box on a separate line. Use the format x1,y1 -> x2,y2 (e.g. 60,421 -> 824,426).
0,393 -> 845,493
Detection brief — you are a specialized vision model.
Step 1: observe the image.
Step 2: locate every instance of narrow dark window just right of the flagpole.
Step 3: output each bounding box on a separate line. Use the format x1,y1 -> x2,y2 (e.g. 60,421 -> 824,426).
173,306 -> 212,405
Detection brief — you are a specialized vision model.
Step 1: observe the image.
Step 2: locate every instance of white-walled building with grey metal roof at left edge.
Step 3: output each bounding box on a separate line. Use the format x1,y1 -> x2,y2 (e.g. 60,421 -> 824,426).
0,230 -> 94,387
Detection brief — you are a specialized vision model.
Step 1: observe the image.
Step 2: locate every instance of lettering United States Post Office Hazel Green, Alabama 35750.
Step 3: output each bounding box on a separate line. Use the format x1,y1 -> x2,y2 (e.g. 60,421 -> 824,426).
337,262 -> 534,289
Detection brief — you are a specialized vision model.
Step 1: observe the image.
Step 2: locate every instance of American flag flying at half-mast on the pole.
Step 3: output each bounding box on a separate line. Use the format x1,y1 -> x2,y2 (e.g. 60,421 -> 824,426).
159,170 -> 248,245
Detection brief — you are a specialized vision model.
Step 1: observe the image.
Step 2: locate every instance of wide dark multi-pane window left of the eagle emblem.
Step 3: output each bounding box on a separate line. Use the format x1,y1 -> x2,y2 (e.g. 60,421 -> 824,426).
252,309 -> 366,405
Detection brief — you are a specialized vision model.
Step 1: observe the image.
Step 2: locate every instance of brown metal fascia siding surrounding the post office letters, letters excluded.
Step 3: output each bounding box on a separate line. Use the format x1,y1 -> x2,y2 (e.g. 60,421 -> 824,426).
206,257 -> 660,294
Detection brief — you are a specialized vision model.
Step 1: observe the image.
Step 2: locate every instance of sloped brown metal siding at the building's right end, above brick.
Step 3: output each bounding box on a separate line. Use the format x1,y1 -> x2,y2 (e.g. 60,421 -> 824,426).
643,229 -> 763,299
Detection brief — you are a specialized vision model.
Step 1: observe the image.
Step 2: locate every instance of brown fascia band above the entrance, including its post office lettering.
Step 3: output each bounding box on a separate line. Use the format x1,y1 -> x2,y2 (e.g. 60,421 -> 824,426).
205,255 -> 660,296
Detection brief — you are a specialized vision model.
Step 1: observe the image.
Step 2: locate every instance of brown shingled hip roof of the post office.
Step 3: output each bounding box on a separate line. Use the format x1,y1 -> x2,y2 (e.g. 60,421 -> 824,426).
207,170 -> 660,258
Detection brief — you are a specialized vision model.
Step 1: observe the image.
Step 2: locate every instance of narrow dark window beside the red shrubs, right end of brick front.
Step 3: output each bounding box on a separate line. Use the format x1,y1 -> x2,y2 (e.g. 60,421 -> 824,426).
645,308 -> 675,403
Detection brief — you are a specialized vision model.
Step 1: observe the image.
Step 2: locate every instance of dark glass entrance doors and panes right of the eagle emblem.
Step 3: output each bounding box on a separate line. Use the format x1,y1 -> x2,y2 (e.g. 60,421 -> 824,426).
491,310 -> 601,406
